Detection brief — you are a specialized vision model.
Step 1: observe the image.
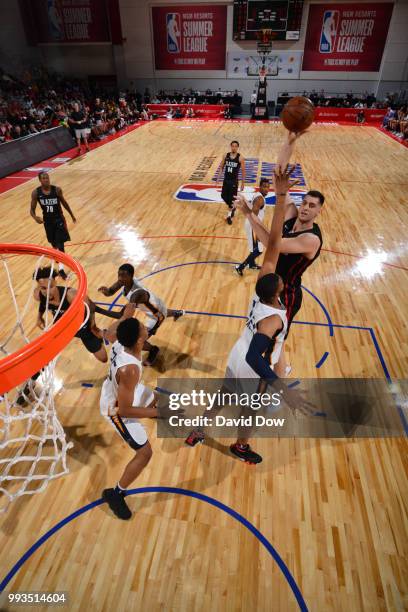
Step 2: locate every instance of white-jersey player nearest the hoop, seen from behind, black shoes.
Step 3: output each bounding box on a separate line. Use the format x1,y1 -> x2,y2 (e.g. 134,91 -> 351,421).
100,316 -> 158,520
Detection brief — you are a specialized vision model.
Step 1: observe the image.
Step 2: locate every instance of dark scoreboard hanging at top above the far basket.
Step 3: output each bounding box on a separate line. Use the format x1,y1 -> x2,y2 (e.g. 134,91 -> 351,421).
233,0 -> 303,40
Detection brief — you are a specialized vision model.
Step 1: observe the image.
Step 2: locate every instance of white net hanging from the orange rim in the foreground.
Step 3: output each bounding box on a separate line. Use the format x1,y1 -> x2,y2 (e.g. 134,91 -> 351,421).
0,255 -> 86,512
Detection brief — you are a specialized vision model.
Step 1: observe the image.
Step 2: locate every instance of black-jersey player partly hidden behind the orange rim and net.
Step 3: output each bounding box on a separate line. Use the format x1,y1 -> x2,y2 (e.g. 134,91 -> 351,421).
34,266 -> 108,363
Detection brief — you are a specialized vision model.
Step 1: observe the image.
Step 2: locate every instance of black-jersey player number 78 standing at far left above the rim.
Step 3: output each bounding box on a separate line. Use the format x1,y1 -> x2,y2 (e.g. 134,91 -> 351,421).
30,172 -> 76,279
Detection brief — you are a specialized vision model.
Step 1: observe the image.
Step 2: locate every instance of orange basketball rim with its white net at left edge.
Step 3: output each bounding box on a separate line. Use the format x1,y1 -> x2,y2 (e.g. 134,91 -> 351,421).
0,244 -> 87,512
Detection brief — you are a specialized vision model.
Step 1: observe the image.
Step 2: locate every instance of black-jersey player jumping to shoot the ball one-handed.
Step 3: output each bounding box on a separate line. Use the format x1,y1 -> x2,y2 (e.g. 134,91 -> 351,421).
239,133 -> 324,377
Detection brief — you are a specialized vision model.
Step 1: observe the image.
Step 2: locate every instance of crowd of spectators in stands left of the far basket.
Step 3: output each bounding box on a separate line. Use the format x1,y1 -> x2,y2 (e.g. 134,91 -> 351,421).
0,68 -> 237,146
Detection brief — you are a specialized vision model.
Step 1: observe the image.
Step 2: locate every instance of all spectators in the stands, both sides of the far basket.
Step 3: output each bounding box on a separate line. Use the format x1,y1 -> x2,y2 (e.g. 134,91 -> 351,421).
0,67 -> 408,146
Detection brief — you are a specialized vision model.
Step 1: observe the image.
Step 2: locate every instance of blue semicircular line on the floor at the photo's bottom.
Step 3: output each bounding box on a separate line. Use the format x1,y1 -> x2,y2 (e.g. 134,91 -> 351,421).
0,487 -> 308,612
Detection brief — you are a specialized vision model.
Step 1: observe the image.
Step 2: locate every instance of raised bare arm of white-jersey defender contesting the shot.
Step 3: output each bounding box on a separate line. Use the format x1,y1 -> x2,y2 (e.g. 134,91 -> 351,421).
258,166 -> 295,278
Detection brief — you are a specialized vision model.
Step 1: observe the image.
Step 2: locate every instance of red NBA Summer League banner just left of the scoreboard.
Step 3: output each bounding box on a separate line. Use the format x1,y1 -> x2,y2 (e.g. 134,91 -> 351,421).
152,4 -> 227,70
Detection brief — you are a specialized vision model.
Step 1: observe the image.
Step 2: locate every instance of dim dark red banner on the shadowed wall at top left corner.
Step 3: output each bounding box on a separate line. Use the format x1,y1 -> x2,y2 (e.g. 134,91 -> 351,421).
31,0 -> 111,43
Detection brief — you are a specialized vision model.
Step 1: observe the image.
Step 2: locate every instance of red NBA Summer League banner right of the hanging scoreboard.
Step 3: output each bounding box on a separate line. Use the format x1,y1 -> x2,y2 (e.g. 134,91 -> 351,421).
302,2 -> 394,72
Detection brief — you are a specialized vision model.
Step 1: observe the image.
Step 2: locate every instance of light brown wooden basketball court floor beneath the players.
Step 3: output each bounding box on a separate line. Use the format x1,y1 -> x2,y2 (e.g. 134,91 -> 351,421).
0,121 -> 408,612
